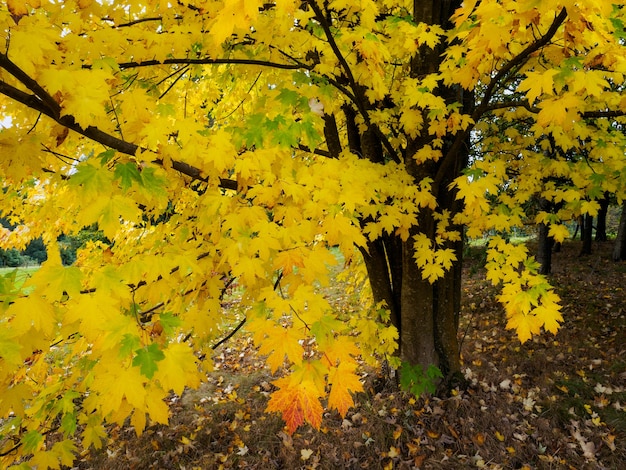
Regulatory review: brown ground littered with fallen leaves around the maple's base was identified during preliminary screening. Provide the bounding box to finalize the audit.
[75,242,626,470]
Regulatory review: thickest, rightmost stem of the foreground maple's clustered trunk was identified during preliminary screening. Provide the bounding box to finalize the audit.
[400,0,464,378]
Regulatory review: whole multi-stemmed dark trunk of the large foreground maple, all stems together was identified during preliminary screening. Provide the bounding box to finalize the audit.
[342,0,473,379]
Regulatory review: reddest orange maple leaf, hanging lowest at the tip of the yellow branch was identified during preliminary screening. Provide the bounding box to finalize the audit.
[266,376,324,434]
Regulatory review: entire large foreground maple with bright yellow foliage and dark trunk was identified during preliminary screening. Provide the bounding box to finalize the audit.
[0,0,626,468]
